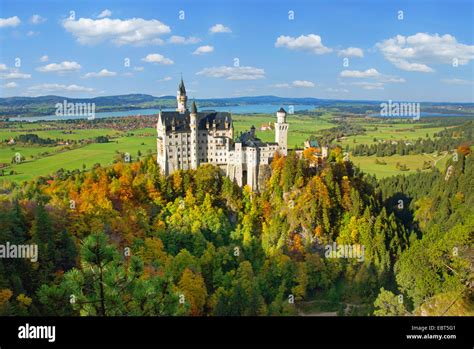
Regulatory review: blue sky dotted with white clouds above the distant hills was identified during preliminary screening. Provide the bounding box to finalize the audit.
[0,0,474,102]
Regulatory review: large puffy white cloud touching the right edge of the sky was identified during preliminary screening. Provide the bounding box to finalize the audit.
[376,33,474,73]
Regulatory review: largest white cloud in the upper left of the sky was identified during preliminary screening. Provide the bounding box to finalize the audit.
[63,18,171,46]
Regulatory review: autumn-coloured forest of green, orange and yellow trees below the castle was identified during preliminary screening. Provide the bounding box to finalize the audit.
[0,148,474,316]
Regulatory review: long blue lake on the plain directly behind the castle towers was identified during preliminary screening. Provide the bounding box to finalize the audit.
[9,104,316,122]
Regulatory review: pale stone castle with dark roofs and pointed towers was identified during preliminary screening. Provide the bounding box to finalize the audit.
[156,78,288,190]
